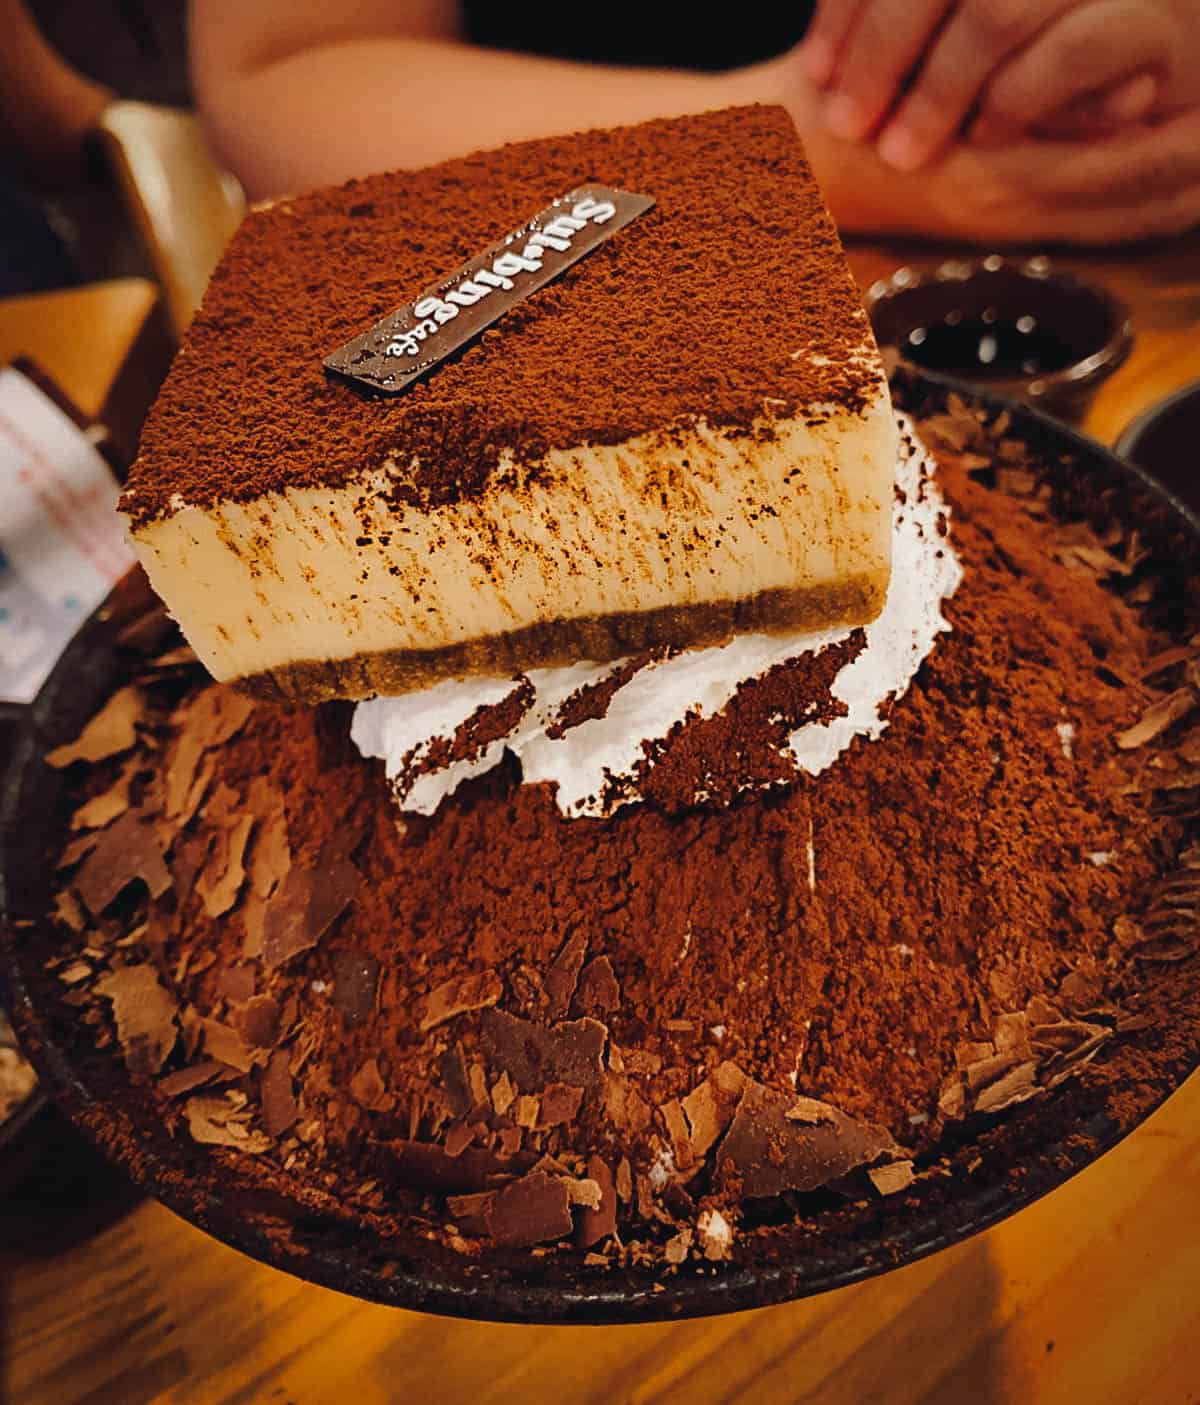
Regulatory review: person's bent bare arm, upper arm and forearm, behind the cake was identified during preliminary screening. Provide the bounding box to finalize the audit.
[191,0,771,195]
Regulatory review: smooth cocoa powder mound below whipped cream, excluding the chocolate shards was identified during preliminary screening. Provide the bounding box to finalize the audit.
[112,449,1162,1137]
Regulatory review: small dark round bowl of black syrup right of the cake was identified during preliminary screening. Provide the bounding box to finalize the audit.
[866,254,1134,420]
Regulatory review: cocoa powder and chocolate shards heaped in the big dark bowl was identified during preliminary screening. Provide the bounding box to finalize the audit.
[42,399,1200,1263]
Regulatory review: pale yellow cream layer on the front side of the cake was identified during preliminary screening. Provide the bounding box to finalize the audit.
[132,396,895,686]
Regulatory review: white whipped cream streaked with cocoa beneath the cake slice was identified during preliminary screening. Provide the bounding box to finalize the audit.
[350,416,963,818]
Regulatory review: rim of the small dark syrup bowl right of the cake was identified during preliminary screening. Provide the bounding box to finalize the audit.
[863,253,1135,398]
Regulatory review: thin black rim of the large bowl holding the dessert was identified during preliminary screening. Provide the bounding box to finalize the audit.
[0,371,1200,1324]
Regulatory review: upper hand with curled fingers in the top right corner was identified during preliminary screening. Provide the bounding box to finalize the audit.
[798,0,1200,170]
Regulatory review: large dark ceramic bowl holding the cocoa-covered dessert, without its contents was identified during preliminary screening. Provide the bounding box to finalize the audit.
[0,372,1200,1322]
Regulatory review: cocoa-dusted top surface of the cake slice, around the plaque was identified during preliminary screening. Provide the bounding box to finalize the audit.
[122,107,878,521]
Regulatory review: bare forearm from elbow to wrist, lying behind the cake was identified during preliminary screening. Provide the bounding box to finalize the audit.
[197,35,773,197]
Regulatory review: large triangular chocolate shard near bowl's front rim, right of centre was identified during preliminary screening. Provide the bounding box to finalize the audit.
[717,1079,896,1198]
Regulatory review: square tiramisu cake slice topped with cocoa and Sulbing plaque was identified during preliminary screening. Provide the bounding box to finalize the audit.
[122,107,896,700]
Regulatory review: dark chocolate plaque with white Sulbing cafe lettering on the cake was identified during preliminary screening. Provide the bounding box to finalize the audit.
[325,184,653,395]
